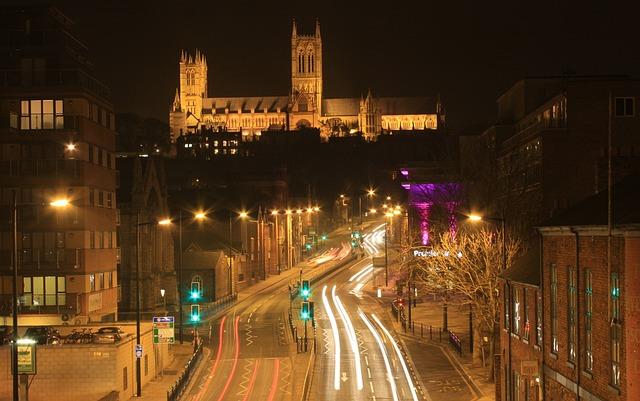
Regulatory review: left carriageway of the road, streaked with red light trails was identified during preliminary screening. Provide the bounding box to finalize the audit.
[184,223,360,401]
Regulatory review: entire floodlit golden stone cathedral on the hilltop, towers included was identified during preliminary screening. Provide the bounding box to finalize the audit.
[169,20,445,142]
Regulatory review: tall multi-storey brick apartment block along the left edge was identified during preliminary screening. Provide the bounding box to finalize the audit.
[0,6,118,325]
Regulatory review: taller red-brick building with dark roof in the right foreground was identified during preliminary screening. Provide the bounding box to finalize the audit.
[539,176,640,401]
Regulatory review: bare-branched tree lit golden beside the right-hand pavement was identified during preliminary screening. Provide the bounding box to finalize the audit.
[405,228,520,378]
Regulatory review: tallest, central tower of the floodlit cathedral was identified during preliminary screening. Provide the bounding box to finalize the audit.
[290,20,322,128]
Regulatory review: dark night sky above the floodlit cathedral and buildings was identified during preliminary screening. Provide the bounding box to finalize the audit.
[46,0,640,128]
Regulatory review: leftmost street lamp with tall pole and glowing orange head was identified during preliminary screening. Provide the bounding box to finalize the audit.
[11,194,71,401]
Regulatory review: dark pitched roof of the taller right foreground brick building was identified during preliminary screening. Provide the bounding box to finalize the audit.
[540,175,640,227]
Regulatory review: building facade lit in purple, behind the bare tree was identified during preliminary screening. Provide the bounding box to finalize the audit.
[402,181,462,245]
